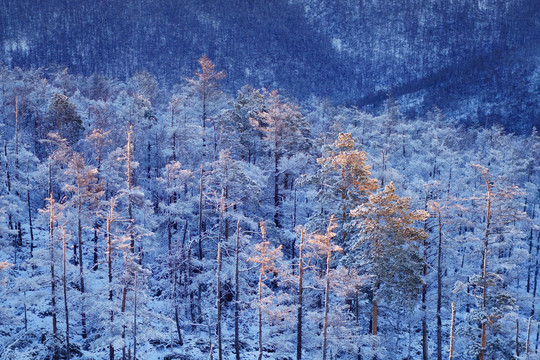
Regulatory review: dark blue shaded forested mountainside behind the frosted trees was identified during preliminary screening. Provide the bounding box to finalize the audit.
[0,0,540,132]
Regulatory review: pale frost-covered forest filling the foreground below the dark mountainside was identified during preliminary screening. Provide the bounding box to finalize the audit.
[0,62,540,359]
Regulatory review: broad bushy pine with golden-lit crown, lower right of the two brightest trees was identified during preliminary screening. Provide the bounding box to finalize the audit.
[351,183,427,358]
